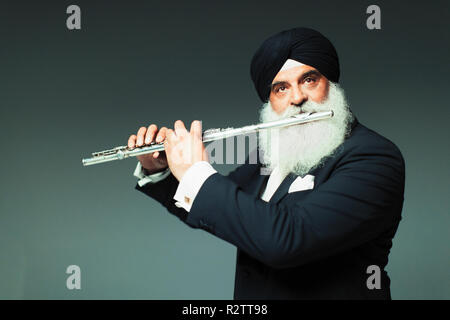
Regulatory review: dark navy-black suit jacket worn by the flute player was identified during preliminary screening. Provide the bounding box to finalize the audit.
[136,119,405,299]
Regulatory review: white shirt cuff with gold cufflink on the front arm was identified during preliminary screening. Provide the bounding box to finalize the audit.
[173,161,217,212]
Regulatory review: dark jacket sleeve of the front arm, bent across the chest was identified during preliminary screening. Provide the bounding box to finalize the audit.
[186,144,404,268]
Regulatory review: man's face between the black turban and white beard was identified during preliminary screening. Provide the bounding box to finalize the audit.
[269,65,329,114]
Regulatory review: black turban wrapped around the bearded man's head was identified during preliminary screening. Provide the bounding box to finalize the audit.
[250,28,339,102]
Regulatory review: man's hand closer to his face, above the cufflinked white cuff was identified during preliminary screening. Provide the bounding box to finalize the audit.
[164,120,208,181]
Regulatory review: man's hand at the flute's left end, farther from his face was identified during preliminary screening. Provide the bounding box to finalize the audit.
[128,124,168,174]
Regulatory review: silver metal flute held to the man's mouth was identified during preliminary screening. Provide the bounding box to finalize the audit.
[81,110,333,166]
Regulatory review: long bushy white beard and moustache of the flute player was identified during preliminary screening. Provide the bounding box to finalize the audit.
[259,82,353,176]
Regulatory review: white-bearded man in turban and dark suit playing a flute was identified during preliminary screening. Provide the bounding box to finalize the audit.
[128,28,405,299]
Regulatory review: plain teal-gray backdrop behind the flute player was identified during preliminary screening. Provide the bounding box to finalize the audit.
[0,0,450,299]
